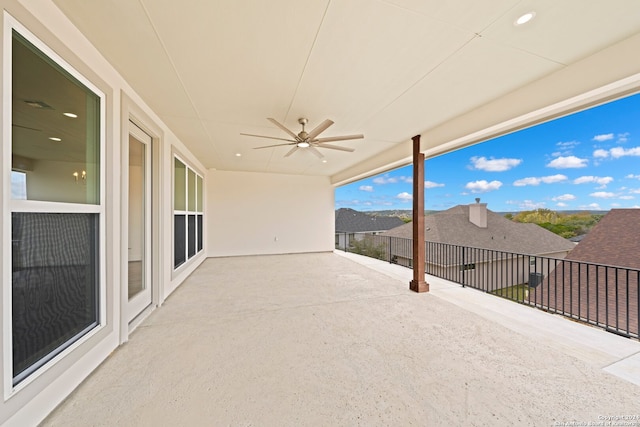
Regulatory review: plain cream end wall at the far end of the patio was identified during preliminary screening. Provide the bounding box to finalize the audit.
[205,170,335,257]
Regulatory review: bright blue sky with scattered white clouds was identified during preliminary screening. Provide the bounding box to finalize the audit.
[335,94,640,212]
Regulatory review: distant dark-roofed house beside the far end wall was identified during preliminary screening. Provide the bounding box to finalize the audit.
[336,208,404,249]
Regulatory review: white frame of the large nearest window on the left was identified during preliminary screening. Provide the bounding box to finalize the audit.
[2,15,107,399]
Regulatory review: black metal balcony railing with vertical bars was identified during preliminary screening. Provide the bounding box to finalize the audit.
[336,233,640,338]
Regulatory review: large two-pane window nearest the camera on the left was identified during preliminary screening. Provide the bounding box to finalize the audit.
[5,30,104,385]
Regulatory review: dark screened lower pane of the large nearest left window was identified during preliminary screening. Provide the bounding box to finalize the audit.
[11,212,99,383]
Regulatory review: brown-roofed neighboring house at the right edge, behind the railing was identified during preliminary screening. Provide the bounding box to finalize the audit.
[535,209,640,336]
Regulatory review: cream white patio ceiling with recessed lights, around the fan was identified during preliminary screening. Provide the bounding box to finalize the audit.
[54,0,640,179]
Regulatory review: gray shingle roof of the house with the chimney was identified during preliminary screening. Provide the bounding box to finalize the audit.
[383,205,575,255]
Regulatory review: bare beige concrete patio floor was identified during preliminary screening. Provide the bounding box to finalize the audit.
[42,253,640,426]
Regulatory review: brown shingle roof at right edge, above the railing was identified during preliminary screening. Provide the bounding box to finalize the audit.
[567,209,640,269]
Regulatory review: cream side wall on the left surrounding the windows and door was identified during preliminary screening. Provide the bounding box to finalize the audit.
[0,0,205,426]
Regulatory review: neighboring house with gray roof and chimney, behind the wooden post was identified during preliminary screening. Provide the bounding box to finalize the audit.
[381,203,575,289]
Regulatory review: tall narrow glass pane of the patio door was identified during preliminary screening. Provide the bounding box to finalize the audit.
[128,136,146,299]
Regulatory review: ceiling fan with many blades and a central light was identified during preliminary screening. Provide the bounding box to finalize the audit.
[240,117,364,159]
